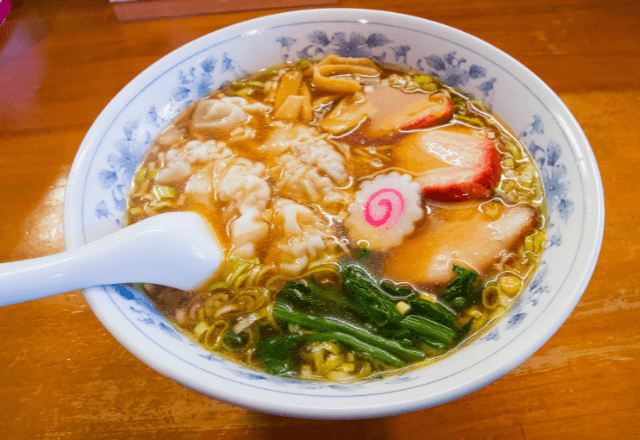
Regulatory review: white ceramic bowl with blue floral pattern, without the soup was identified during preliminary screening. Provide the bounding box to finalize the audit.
[64,9,604,419]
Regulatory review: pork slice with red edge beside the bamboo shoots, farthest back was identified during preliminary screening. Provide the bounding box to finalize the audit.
[365,87,453,137]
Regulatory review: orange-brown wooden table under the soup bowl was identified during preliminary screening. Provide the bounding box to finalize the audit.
[0,0,640,440]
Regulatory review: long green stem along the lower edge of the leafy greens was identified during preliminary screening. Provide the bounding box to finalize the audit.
[273,302,425,362]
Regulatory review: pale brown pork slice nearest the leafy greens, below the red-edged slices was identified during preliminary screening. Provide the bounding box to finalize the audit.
[383,202,538,285]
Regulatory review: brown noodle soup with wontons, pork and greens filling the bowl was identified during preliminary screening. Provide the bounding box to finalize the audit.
[128,56,545,380]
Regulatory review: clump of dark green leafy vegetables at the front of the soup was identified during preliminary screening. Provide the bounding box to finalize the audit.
[258,262,481,376]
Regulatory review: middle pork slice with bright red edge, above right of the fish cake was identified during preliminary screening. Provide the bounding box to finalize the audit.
[392,125,500,202]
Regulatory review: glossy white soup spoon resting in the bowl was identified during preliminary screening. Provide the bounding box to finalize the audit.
[0,212,222,306]
